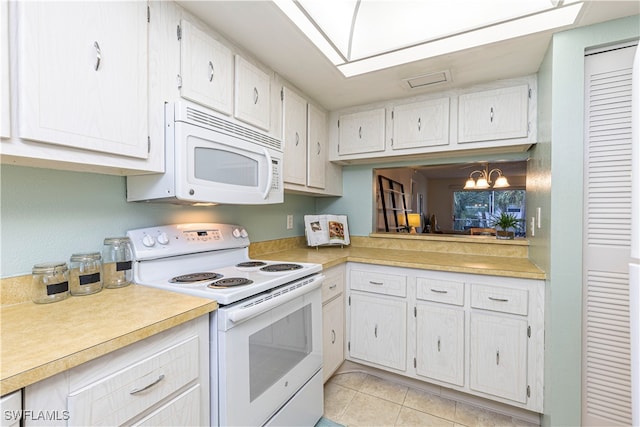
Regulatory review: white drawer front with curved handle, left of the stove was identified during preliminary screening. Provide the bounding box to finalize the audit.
[67,337,199,426]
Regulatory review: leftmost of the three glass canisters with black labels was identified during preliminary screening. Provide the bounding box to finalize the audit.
[31,262,69,304]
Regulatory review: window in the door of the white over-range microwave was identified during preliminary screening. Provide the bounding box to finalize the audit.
[194,147,260,187]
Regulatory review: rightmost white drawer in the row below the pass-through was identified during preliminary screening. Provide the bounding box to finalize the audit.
[471,283,529,316]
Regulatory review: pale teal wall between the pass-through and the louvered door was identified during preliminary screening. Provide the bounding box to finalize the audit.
[527,16,640,426]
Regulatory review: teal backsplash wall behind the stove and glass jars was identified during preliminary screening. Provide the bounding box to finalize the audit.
[0,165,315,277]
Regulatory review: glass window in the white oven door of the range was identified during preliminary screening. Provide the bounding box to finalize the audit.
[249,304,313,402]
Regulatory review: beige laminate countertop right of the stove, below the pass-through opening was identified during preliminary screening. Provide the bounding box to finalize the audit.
[258,246,545,279]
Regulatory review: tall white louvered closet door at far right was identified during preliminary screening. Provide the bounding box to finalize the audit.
[582,41,640,426]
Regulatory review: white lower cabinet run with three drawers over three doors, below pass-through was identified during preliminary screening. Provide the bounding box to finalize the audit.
[346,263,544,413]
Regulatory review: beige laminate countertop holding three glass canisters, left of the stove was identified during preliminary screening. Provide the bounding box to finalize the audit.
[0,285,218,395]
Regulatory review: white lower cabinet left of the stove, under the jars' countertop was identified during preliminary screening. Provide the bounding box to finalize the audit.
[24,316,210,426]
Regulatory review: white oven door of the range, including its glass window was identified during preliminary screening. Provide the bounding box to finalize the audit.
[218,276,323,426]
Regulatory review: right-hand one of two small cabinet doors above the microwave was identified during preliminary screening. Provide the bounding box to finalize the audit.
[235,55,271,131]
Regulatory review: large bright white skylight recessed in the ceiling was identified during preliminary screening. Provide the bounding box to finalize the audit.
[273,0,582,77]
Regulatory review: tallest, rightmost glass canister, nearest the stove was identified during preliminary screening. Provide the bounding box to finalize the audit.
[102,237,132,289]
